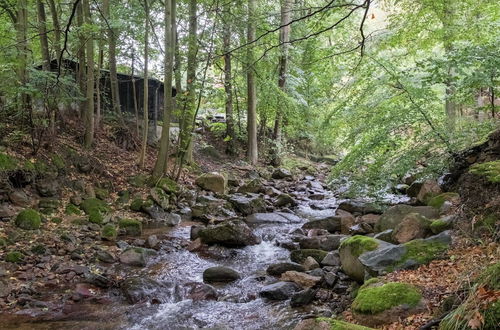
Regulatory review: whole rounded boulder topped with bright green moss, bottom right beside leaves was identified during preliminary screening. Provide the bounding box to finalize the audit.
[351,281,424,327]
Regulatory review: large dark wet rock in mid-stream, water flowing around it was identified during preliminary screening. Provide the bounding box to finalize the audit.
[199,220,260,247]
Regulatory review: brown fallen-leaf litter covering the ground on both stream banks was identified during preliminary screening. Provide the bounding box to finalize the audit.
[0,122,500,330]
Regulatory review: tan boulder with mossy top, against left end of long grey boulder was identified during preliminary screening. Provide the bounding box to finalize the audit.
[339,235,389,282]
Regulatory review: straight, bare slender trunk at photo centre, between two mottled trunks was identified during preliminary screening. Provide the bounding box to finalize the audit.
[246,0,258,165]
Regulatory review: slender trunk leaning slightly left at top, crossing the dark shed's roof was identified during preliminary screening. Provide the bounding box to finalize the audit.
[103,0,121,116]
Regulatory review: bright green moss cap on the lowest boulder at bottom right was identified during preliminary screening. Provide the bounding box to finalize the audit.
[351,282,422,314]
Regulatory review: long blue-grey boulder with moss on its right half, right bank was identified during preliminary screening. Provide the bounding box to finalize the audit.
[359,231,451,276]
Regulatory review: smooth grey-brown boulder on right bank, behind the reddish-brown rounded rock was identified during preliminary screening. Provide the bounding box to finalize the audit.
[374,204,439,233]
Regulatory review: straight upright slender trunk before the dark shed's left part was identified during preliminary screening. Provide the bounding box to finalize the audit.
[83,0,94,148]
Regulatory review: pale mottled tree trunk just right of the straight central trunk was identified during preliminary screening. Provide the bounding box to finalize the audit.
[273,0,292,166]
